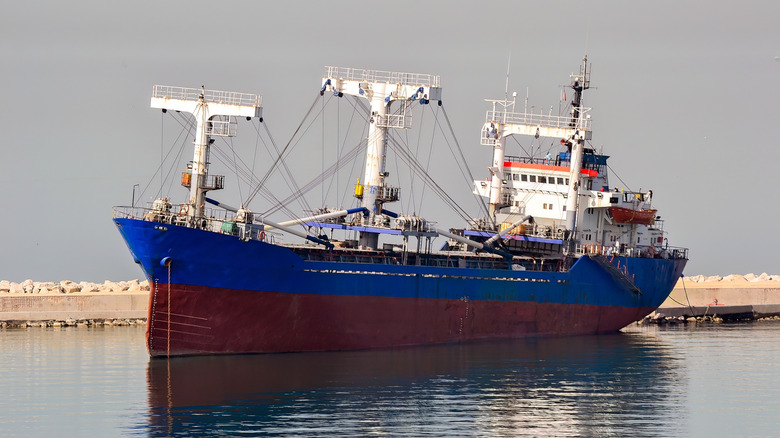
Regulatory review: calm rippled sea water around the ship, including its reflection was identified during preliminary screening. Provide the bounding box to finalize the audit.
[0,321,780,437]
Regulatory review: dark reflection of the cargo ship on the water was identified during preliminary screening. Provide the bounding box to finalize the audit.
[146,333,687,436]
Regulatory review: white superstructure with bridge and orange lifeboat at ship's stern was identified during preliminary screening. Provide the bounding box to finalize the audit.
[474,57,663,254]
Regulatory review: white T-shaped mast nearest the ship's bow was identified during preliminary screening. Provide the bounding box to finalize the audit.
[151,85,263,225]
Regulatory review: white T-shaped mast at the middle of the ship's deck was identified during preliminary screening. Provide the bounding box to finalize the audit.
[321,67,441,249]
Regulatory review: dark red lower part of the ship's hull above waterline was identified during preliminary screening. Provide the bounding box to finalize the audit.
[146,284,654,356]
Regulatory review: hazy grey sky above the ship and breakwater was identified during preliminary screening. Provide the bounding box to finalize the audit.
[0,0,780,282]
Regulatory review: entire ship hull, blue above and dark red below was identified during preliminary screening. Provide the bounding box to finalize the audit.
[114,219,687,355]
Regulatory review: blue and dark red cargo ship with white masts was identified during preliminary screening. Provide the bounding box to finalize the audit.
[113,57,688,357]
